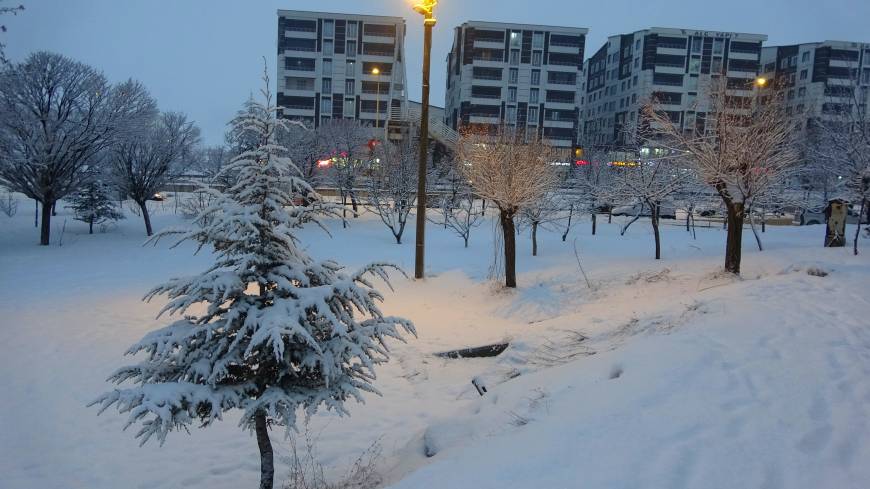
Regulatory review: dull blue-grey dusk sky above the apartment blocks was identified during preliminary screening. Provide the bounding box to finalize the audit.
[2,0,870,144]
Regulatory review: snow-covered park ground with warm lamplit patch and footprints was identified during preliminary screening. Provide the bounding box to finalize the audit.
[0,195,870,489]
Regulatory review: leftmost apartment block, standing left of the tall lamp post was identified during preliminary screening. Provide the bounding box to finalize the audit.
[277,10,408,132]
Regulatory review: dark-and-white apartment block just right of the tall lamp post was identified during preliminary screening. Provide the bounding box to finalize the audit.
[445,21,588,153]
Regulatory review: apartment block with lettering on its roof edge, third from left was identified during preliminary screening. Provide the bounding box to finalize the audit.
[578,27,767,148]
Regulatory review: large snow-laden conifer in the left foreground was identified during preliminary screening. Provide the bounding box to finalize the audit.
[92,67,415,489]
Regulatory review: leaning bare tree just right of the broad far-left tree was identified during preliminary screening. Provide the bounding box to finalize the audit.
[111,112,199,236]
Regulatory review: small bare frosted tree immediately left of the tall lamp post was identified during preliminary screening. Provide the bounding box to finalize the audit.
[368,138,420,244]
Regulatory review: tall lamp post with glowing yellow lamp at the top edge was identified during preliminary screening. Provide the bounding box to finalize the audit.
[414,0,438,279]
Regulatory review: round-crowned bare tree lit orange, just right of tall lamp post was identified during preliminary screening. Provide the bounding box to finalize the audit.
[459,127,558,287]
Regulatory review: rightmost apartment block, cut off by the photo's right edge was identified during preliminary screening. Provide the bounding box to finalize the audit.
[761,41,870,133]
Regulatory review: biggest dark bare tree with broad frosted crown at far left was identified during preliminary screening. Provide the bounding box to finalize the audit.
[0,52,156,246]
